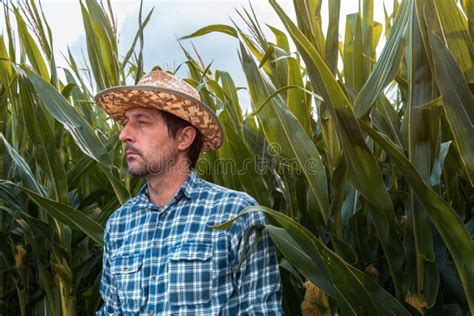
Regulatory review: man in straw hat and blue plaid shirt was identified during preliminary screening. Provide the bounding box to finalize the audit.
[96,71,282,315]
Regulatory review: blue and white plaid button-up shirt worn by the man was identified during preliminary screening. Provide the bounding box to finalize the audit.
[97,170,283,315]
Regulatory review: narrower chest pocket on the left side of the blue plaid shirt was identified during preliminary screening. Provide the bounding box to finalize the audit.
[110,254,145,312]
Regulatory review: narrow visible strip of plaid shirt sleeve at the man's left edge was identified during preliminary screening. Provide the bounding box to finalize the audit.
[96,223,122,316]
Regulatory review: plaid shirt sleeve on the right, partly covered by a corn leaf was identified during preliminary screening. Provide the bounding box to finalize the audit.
[231,202,283,315]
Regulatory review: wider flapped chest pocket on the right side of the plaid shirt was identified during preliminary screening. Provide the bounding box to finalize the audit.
[168,243,212,306]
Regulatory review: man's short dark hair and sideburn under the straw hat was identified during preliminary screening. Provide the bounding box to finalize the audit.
[160,111,202,168]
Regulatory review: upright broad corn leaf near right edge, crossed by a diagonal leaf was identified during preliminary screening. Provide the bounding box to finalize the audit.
[405,7,439,308]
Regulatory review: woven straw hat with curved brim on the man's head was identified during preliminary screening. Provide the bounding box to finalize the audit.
[95,70,224,151]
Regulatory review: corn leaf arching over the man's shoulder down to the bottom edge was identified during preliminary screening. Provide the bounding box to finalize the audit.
[213,206,409,315]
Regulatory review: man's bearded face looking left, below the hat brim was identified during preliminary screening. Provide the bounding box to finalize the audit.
[119,108,178,178]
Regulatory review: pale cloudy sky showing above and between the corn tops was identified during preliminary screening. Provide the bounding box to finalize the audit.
[0,0,393,107]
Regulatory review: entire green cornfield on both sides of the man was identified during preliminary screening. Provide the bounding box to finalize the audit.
[0,0,474,315]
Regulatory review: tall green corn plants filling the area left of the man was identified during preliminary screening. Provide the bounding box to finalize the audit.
[0,0,146,315]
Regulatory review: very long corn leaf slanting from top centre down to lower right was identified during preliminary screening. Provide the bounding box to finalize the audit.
[270,0,405,297]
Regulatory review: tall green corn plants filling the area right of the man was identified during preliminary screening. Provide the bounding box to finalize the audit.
[184,0,474,315]
